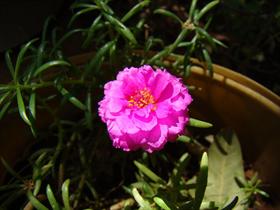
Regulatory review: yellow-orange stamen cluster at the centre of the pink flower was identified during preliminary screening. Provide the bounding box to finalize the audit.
[128,88,156,110]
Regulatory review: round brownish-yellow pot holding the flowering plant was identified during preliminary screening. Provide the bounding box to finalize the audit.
[0,53,280,206]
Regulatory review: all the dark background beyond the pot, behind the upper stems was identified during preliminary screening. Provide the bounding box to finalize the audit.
[0,0,280,95]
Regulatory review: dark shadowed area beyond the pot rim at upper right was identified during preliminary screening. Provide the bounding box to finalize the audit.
[212,0,280,94]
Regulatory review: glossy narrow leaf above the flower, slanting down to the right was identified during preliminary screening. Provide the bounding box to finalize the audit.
[103,13,137,44]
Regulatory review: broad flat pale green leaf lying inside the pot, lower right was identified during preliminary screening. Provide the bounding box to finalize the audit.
[205,130,246,210]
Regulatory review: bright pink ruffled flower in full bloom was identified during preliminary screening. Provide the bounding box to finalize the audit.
[98,65,192,153]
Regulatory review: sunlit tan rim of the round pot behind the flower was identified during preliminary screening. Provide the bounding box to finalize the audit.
[70,51,280,117]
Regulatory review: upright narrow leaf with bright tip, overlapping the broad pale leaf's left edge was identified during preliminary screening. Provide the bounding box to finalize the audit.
[193,152,208,210]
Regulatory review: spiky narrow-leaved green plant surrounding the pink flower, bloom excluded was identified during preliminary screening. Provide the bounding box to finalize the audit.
[0,0,270,210]
